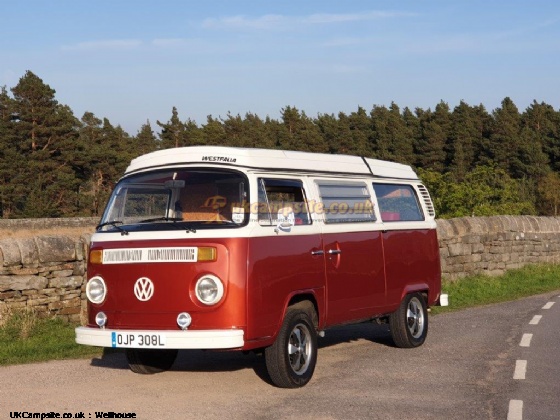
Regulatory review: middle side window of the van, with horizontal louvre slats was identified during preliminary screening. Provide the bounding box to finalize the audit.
[317,181,375,223]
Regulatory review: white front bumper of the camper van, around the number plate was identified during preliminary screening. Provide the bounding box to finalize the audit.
[76,327,244,349]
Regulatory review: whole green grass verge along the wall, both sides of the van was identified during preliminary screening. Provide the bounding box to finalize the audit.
[0,265,560,365]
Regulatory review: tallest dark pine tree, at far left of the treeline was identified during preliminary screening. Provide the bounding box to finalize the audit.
[11,71,79,217]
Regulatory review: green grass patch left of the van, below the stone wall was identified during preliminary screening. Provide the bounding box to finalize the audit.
[0,312,102,365]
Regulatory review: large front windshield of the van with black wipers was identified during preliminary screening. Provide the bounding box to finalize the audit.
[98,169,248,232]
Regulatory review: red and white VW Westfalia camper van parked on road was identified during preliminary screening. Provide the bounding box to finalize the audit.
[76,146,441,388]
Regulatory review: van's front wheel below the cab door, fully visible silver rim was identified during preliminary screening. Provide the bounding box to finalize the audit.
[264,302,317,388]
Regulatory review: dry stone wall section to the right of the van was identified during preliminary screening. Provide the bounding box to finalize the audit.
[438,216,560,280]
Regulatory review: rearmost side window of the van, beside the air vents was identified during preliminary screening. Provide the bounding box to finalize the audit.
[373,183,424,222]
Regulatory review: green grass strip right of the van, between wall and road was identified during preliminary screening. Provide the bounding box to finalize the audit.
[433,265,560,313]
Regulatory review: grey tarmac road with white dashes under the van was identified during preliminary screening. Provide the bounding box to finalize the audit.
[0,292,560,420]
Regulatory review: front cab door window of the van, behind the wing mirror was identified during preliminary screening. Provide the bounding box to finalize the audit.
[259,178,311,226]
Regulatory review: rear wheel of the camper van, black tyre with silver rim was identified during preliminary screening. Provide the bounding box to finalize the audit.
[389,293,428,348]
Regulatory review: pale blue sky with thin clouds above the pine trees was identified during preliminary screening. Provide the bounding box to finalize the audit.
[0,0,560,134]
